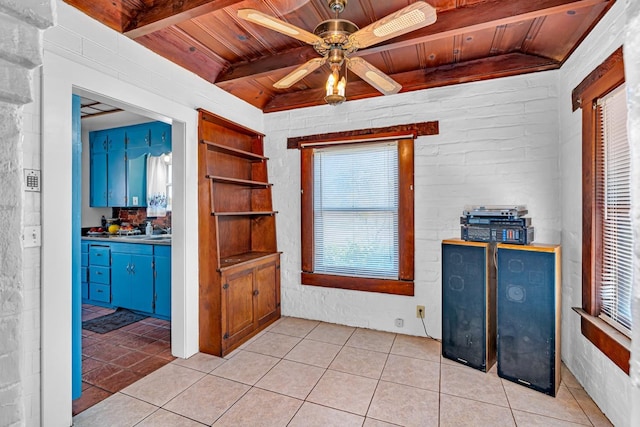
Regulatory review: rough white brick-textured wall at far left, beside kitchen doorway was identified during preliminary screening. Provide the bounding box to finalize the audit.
[0,0,53,426]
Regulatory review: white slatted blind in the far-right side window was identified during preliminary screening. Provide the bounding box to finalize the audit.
[597,85,633,334]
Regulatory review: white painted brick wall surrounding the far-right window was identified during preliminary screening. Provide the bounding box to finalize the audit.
[558,1,640,426]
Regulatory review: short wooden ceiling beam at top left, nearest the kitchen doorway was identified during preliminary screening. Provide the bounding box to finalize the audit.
[124,0,242,39]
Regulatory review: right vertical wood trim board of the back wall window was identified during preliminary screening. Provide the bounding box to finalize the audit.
[398,139,415,280]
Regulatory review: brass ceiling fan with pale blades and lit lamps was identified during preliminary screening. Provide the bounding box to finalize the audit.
[238,0,436,105]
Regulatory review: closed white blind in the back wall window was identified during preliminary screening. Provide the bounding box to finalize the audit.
[313,142,399,279]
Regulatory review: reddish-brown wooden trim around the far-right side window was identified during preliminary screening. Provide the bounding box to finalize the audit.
[572,48,631,374]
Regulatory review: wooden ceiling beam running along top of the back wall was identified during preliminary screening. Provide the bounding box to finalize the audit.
[263,53,561,113]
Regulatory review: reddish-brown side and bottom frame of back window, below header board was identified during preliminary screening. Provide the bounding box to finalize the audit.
[300,134,415,296]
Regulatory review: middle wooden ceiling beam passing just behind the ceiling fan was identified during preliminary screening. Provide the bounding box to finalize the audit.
[216,0,611,83]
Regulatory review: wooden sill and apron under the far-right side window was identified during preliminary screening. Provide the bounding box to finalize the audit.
[573,307,631,375]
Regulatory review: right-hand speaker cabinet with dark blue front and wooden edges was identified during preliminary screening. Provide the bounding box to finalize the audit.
[497,243,561,396]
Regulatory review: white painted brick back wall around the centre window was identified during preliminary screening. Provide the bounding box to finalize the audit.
[265,72,560,337]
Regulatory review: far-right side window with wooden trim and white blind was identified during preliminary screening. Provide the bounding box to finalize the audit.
[573,49,633,373]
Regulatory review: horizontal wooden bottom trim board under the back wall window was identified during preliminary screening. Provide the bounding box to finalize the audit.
[302,273,414,296]
